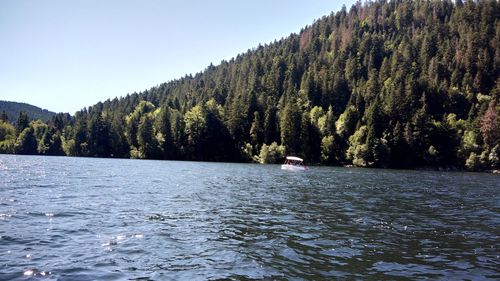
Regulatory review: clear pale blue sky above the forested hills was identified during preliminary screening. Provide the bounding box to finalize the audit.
[0,0,355,114]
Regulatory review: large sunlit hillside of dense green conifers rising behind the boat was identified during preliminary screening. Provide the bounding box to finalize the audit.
[0,0,500,170]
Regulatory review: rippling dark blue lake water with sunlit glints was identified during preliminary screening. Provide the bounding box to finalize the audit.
[0,155,500,280]
